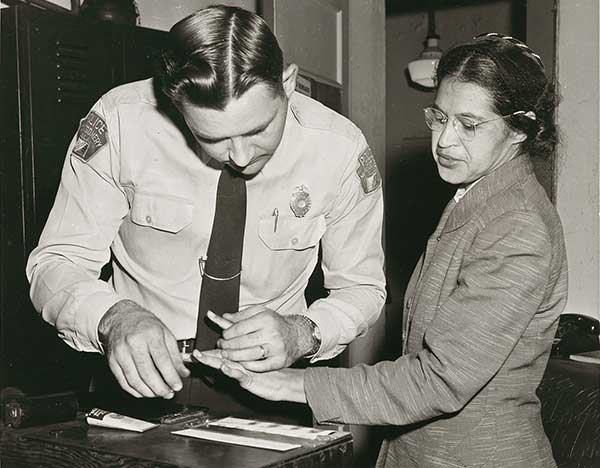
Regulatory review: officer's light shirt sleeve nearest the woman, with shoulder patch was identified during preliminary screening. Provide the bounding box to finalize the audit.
[306,136,385,361]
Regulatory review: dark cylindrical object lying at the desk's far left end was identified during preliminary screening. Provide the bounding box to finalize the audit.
[0,387,79,428]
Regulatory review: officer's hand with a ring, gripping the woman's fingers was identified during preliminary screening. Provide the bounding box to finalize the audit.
[208,306,312,372]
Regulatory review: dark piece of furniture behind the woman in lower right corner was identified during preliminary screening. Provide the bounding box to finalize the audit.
[538,357,600,468]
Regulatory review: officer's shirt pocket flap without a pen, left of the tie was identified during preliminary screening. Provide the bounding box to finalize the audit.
[131,193,193,233]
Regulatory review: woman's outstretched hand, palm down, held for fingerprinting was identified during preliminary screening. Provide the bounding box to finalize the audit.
[192,349,306,403]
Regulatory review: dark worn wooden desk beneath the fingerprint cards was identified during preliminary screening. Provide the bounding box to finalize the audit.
[0,420,352,468]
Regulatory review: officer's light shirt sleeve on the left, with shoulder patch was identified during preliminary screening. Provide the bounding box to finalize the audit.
[26,100,128,352]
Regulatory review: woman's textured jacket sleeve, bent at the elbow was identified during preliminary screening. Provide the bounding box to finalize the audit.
[305,212,551,425]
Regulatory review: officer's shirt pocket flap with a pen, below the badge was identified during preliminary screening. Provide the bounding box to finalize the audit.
[258,216,325,250]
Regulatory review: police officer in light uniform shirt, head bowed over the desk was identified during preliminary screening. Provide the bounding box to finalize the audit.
[27,6,385,410]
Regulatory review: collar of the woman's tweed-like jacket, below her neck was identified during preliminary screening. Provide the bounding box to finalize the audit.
[443,155,533,233]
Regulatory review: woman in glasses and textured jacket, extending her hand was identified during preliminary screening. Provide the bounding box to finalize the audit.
[196,33,567,468]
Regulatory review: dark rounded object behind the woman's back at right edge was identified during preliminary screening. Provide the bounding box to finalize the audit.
[552,314,600,357]
